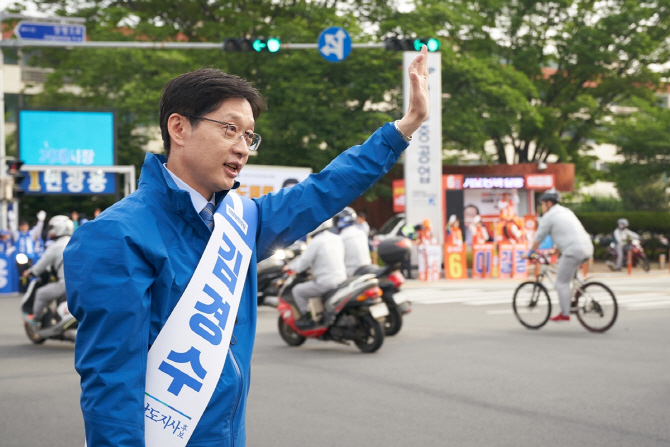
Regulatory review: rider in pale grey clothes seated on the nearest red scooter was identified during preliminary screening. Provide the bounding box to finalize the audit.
[286,219,347,330]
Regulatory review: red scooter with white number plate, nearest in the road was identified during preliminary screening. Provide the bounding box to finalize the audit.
[277,273,388,353]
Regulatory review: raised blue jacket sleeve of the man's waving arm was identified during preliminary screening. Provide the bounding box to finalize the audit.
[254,123,408,260]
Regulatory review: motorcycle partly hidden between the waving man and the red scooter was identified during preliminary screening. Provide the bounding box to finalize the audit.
[256,241,305,307]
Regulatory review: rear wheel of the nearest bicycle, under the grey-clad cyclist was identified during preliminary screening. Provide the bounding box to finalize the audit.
[572,282,619,332]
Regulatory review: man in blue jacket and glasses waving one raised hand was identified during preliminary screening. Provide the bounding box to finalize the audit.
[64,47,428,447]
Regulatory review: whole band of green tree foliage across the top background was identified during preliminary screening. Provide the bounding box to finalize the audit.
[10,0,670,191]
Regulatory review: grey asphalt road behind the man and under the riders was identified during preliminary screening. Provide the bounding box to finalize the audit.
[0,273,670,447]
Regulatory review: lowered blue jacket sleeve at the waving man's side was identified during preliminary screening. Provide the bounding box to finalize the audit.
[64,218,153,447]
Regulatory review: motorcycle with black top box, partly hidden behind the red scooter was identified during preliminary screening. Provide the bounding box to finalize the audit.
[355,237,412,336]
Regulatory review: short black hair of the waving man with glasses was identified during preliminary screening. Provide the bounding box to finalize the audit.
[159,68,267,158]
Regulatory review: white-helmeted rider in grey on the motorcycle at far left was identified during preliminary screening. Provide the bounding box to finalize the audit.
[23,216,74,328]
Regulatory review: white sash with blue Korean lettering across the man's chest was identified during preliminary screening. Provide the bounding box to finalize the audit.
[144,192,258,447]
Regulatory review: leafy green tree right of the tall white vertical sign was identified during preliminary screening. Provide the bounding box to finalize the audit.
[406,0,670,175]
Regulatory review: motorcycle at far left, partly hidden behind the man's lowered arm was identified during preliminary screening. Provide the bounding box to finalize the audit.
[21,258,78,345]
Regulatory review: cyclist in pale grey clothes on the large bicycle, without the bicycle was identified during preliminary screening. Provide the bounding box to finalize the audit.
[528,189,593,321]
